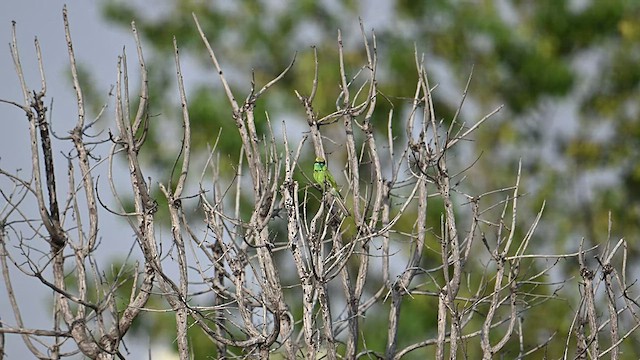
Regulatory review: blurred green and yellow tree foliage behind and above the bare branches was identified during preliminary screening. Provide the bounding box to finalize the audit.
[85,0,640,354]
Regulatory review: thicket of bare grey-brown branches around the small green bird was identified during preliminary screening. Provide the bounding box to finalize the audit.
[0,9,640,359]
